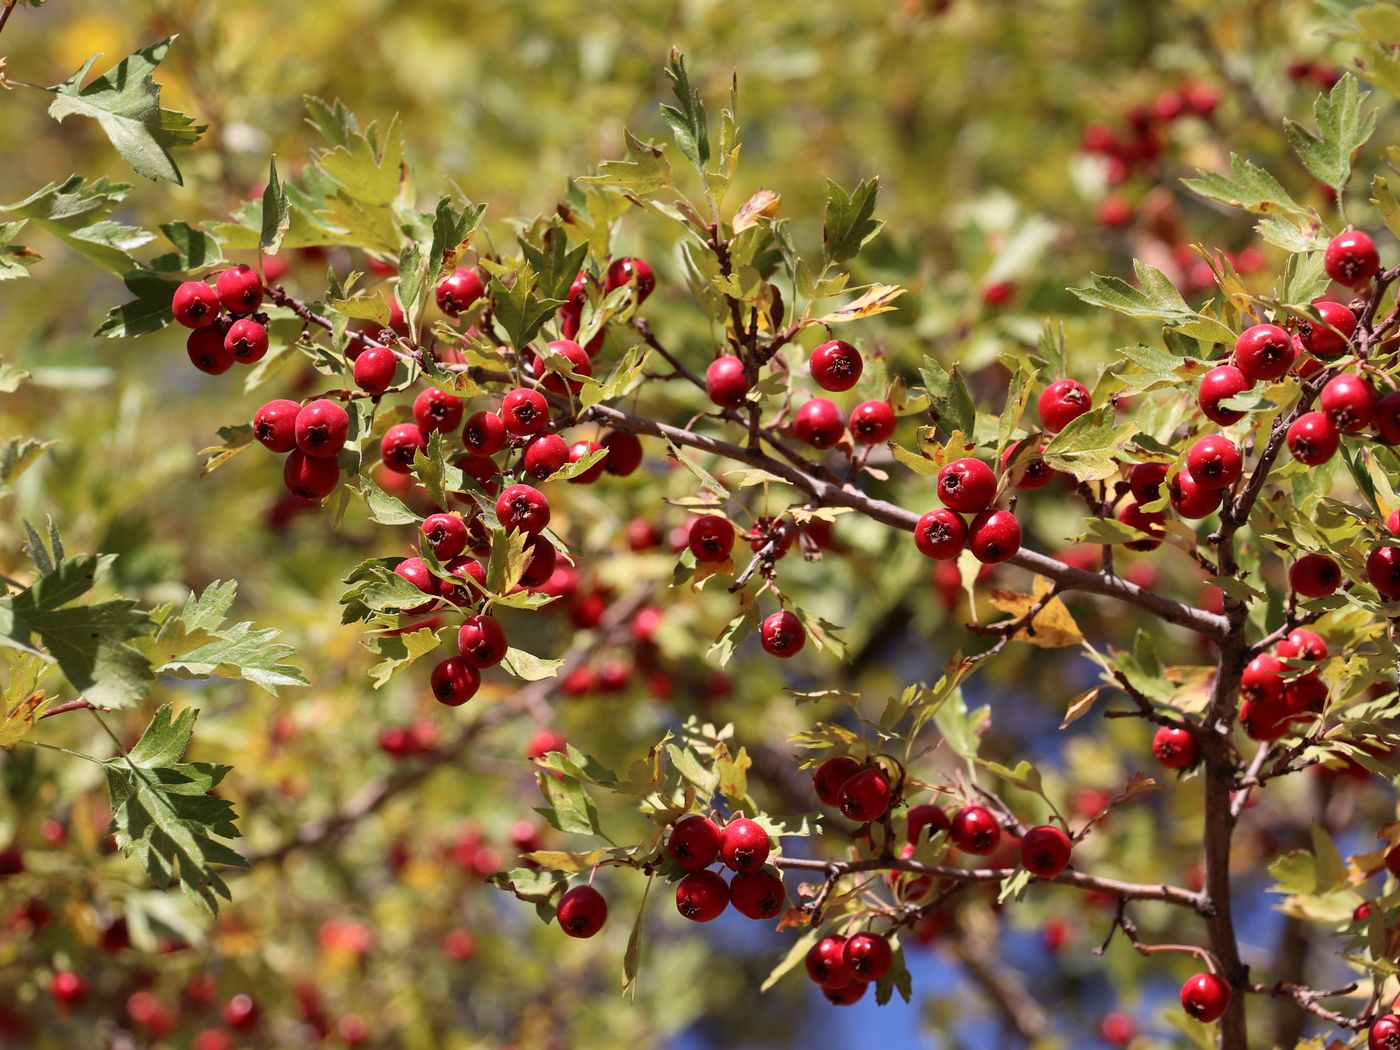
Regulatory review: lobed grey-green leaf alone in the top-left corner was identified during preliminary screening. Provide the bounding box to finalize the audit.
[48,36,203,185]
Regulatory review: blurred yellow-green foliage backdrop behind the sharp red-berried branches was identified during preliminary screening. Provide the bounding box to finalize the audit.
[0,0,1383,1050]
